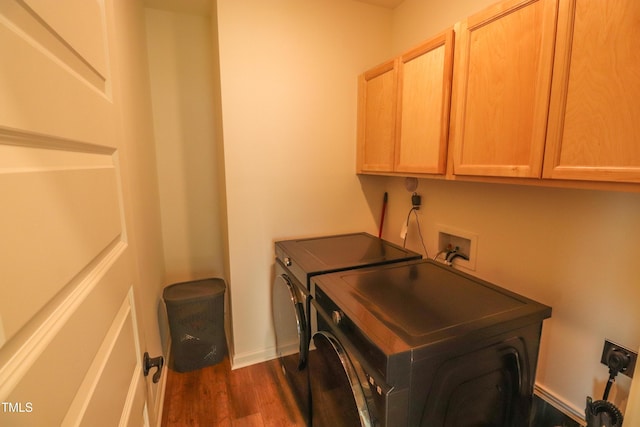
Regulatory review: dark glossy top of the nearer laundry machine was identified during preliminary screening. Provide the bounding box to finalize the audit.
[313,260,551,358]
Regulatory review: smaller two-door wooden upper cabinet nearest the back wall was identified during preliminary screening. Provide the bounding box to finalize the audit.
[357,29,454,174]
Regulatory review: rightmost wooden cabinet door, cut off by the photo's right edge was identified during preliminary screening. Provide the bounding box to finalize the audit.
[544,0,640,182]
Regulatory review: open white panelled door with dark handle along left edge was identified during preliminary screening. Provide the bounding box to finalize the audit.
[0,0,148,427]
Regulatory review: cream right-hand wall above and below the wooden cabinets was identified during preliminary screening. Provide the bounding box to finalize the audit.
[385,0,640,414]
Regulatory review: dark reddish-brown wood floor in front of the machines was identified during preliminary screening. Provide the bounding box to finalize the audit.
[162,356,304,427]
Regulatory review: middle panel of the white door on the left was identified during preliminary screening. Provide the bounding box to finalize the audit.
[0,146,123,346]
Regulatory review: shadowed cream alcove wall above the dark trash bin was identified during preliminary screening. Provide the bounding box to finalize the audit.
[146,8,224,284]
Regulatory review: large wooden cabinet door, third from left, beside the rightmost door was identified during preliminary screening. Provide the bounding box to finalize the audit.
[452,0,557,177]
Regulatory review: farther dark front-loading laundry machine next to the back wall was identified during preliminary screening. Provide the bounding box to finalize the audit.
[272,233,422,421]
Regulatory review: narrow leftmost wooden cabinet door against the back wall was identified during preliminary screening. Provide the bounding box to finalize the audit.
[356,60,398,173]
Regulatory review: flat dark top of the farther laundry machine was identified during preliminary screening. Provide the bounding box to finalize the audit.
[275,233,422,276]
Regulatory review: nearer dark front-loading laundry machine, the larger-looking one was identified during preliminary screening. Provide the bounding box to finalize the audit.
[307,260,551,427]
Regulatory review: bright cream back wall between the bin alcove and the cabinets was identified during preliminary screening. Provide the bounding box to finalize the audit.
[217,0,391,366]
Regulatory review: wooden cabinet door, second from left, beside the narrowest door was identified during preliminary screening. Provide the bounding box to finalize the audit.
[395,30,454,174]
